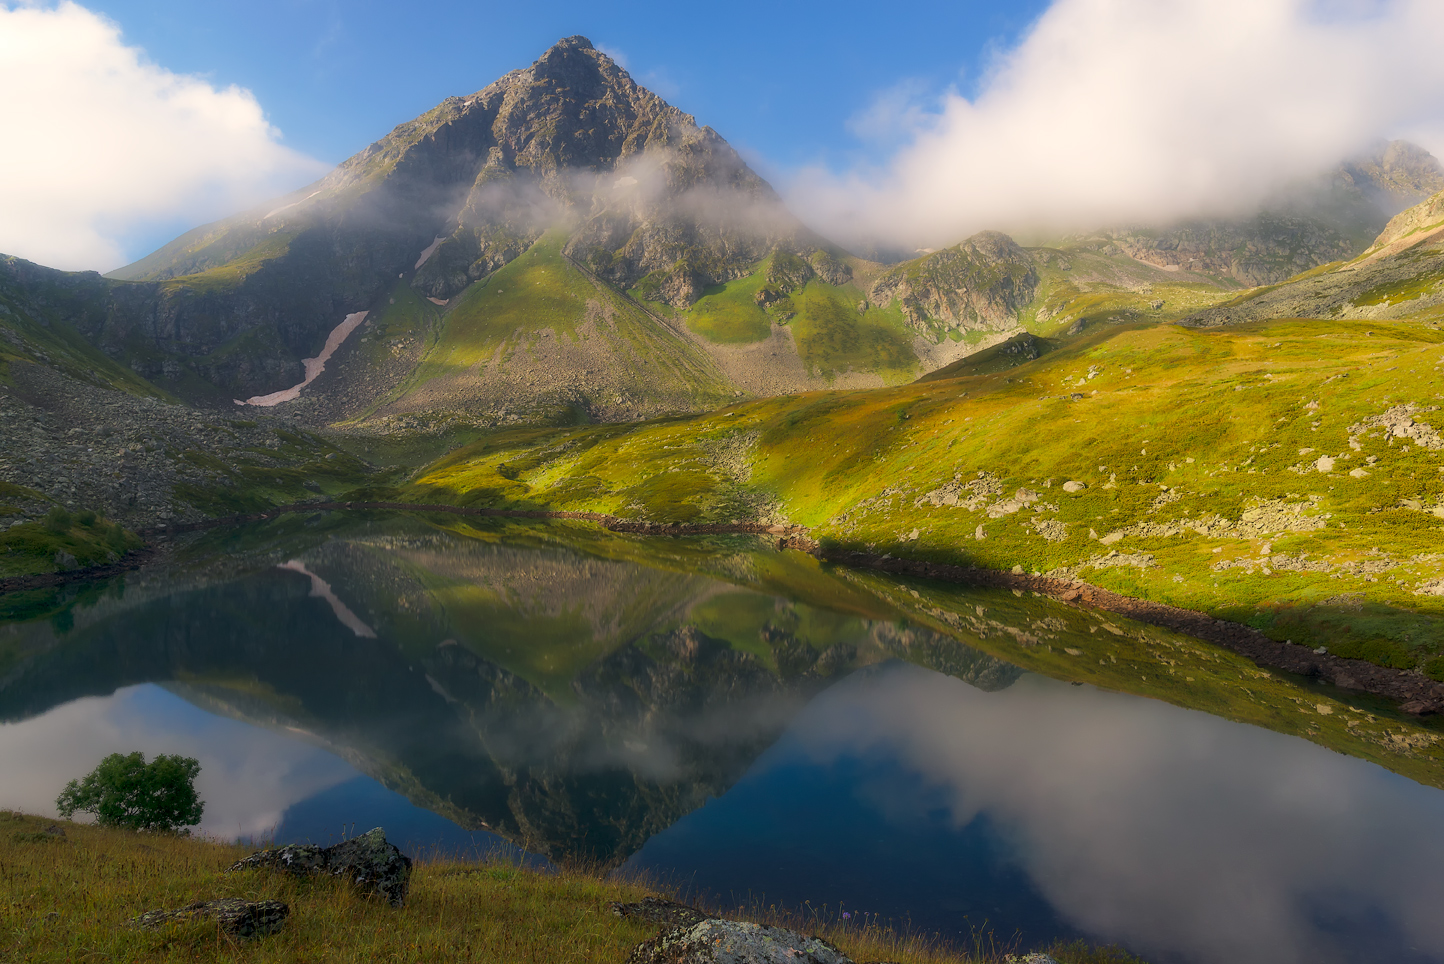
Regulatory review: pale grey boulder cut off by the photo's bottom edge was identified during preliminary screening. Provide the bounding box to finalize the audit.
[627,919,852,964]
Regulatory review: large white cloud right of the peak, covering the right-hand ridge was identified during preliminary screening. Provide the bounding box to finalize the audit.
[790,0,1444,247]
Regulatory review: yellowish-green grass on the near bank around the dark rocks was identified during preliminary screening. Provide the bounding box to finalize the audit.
[0,812,1114,964]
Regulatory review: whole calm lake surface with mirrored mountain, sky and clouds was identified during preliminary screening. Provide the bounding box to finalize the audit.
[0,520,1444,964]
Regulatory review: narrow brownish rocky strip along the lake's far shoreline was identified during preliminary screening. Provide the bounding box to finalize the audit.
[8,501,1444,716]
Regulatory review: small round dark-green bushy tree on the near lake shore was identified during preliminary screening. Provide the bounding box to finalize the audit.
[55,752,205,831]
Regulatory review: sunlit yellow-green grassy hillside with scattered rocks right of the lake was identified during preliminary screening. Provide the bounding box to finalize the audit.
[406,313,1444,675]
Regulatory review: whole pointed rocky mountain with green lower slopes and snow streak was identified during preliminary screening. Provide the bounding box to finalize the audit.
[0,38,1062,431]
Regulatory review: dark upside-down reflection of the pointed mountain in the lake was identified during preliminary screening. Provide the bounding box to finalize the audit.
[0,534,1019,866]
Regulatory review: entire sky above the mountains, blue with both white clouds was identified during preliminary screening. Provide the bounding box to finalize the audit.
[0,0,1444,270]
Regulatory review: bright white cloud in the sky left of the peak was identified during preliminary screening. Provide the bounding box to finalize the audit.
[0,3,325,270]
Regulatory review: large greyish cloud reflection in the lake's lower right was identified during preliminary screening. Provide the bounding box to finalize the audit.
[785,665,1444,964]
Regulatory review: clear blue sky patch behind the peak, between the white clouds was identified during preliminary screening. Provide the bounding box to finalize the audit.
[85,0,1047,176]
